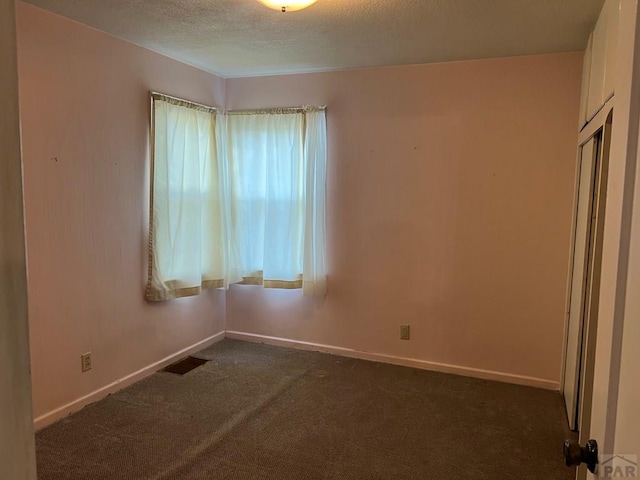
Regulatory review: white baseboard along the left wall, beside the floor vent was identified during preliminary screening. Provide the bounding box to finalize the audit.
[33,331,225,430]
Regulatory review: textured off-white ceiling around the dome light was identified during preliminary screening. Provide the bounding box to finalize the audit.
[22,0,603,77]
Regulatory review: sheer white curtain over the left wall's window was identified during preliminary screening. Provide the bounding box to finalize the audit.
[146,96,225,301]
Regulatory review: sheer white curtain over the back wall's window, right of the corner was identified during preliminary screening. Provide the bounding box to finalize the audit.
[226,108,327,295]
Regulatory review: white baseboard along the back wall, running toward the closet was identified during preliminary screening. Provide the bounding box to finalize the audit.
[226,330,560,391]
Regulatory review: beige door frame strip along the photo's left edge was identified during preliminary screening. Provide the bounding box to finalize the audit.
[0,0,37,480]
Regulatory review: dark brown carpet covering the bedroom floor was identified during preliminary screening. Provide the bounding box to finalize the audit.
[36,340,574,480]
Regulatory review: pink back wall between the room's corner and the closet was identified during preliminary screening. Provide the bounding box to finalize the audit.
[227,53,582,387]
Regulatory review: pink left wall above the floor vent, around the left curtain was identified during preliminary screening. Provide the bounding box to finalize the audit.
[17,2,225,424]
